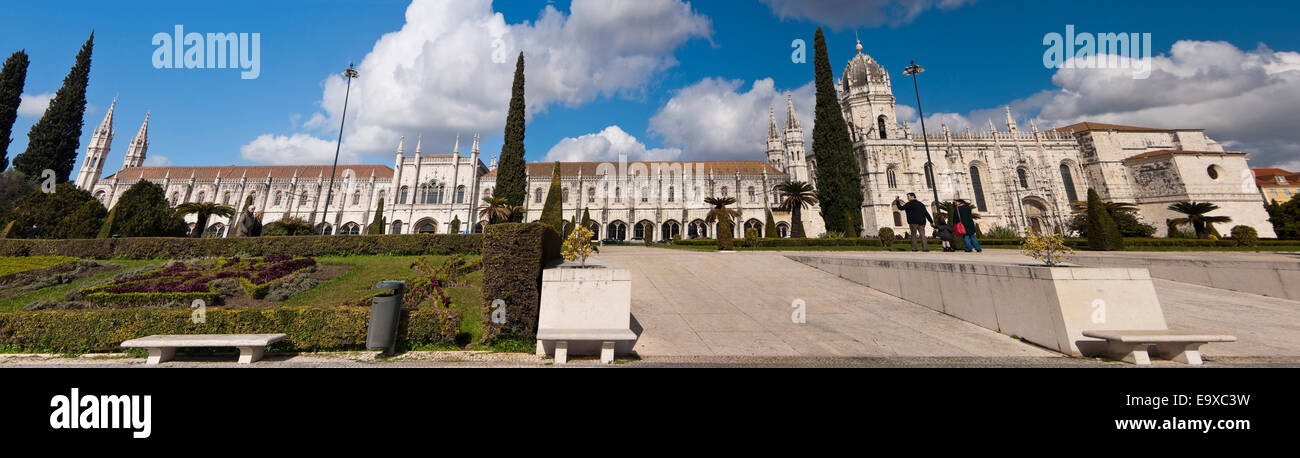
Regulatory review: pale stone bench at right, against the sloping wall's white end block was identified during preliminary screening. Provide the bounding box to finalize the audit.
[1083,330,1236,364]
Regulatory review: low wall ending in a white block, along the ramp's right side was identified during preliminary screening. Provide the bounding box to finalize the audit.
[787,255,1167,355]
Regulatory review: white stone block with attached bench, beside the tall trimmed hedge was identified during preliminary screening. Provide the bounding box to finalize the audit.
[537,259,641,355]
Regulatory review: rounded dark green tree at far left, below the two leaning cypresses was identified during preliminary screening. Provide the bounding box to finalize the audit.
[8,182,107,238]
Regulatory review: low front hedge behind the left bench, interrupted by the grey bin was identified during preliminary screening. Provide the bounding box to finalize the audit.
[0,306,460,353]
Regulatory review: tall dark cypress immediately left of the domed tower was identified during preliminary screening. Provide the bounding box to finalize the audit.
[813,27,863,234]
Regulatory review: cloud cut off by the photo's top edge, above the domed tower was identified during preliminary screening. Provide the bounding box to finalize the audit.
[762,0,975,30]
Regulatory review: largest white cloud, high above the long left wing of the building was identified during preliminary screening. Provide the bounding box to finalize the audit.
[241,0,712,164]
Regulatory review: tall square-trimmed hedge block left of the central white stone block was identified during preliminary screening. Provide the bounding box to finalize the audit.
[482,222,560,338]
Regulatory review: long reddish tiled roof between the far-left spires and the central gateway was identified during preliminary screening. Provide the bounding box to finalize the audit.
[101,164,393,181]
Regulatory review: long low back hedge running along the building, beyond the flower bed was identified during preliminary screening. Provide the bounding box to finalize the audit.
[0,234,484,259]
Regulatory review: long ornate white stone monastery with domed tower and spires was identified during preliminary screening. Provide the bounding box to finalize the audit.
[77,38,1274,241]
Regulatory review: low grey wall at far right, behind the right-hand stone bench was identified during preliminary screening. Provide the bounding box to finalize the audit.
[1070,254,1300,301]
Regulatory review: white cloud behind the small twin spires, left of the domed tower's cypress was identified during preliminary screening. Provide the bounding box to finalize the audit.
[649,78,815,160]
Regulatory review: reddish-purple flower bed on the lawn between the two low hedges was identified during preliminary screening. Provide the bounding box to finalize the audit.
[81,255,316,306]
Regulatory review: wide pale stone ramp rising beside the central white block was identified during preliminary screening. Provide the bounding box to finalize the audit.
[598,246,1060,359]
